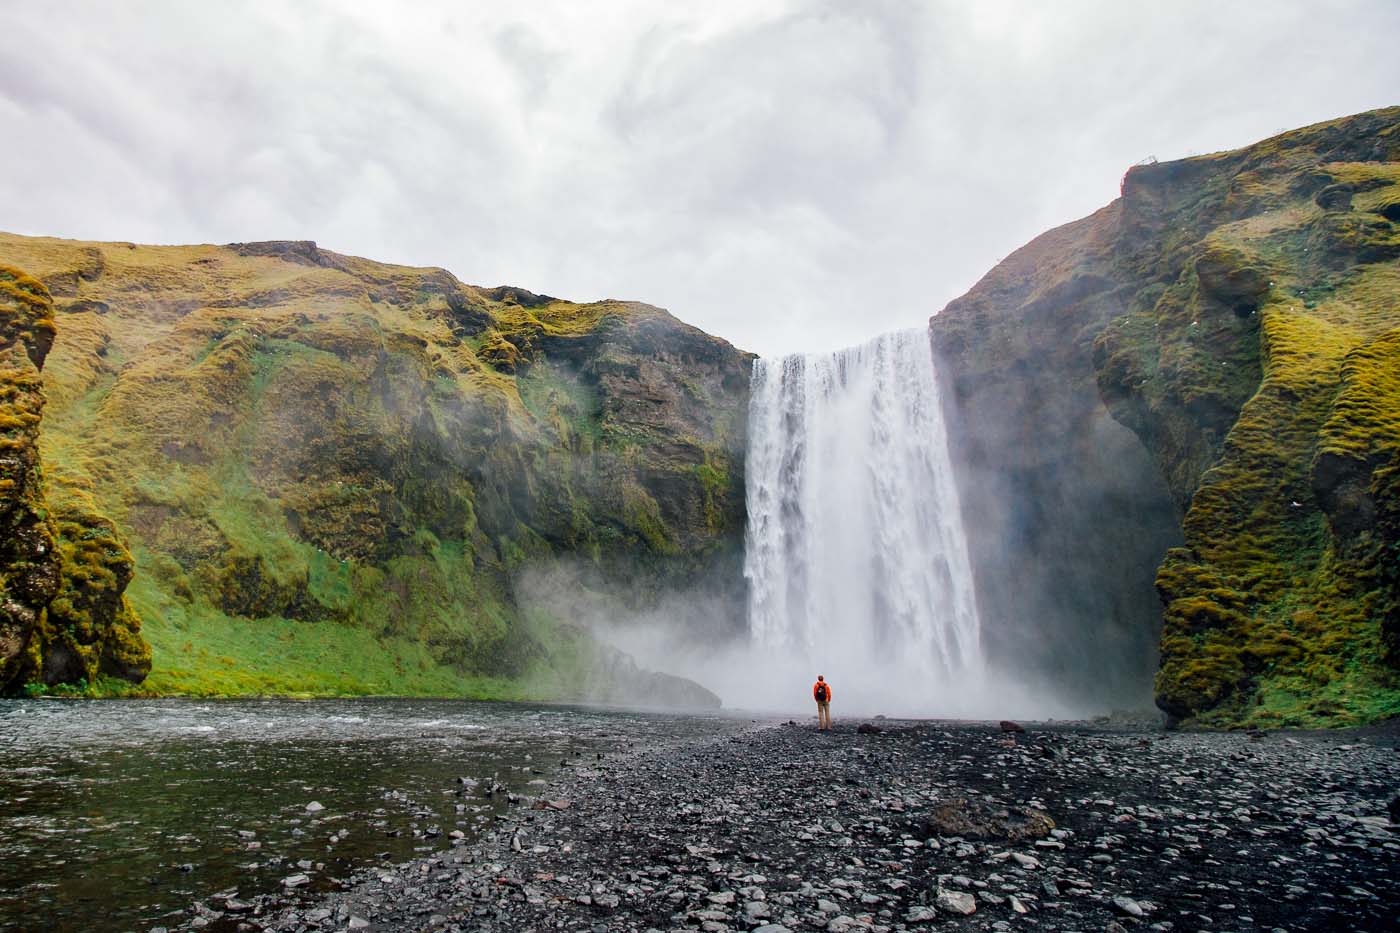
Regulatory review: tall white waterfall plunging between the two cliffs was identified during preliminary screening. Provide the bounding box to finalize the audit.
[745,329,984,713]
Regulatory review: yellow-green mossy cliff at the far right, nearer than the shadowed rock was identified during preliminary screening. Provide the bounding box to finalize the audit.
[1096,109,1400,726]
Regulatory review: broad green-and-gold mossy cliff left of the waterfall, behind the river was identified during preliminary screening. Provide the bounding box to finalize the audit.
[0,234,749,696]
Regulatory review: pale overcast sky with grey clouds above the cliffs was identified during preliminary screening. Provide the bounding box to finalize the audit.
[0,0,1400,354]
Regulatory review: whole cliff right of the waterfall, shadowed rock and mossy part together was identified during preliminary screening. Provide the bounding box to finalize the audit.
[932,108,1400,726]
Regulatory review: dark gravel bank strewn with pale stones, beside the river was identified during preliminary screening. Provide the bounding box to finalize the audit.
[195,721,1400,933]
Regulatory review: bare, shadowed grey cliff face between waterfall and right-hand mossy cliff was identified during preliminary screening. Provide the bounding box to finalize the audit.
[931,205,1180,707]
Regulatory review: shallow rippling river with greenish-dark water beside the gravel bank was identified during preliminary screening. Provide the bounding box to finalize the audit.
[0,699,749,930]
